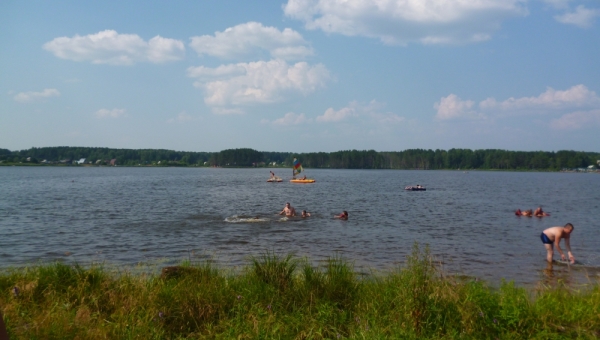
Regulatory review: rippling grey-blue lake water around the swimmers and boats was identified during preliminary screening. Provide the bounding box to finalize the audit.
[0,167,600,285]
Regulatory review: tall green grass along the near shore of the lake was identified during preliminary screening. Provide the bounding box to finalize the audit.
[0,245,600,339]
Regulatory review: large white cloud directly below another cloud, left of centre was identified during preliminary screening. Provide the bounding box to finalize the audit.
[187,59,331,106]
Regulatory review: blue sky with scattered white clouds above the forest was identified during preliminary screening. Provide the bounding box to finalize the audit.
[0,0,600,152]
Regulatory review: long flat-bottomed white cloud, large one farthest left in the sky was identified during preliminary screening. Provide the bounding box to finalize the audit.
[43,30,185,65]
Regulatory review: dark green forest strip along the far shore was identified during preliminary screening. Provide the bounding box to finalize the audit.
[0,146,600,171]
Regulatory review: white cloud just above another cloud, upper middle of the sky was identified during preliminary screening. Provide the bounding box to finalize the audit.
[190,22,314,60]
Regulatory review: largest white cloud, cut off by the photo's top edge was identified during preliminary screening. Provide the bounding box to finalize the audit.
[284,0,528,45]
